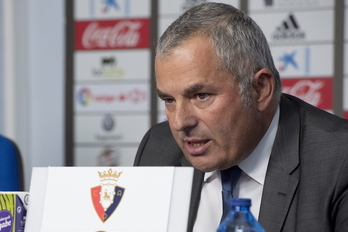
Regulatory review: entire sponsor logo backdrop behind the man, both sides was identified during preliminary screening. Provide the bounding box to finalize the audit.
[67,0,348,166]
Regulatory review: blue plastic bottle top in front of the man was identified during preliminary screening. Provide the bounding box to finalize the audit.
[217,198,265,232]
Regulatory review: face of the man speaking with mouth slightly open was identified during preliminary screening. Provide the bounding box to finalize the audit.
[155,37,260,171]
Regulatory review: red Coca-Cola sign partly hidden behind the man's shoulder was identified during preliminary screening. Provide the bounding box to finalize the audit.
[282,78,332,109]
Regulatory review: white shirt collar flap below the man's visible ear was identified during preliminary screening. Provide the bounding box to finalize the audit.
[238,106,279,185]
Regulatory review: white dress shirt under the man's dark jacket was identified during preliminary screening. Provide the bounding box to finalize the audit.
[193,106,279,232]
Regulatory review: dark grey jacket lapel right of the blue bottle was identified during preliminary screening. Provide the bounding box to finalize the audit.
[259,96,301,231]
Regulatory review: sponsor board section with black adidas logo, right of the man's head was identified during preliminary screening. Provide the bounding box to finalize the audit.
[249,0,334,111]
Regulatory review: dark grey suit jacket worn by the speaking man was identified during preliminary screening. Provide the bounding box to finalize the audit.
[134,94,348,232]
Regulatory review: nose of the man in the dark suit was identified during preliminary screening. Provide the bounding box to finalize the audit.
[167,102,198,131]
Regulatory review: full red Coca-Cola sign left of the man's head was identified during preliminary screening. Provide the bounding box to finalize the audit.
[75,19,150,50]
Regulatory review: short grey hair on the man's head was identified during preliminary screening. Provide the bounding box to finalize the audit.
[156,2,281,108]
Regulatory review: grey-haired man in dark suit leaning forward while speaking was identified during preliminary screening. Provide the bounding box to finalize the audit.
[134,3,348,232]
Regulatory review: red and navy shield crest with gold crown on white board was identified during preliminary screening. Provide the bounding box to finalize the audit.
[91,168,125,222]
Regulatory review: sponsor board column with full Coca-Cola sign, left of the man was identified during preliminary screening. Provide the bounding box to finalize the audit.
[70,0,151,166]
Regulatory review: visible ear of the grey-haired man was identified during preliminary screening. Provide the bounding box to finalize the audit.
[253,68,275,112]
